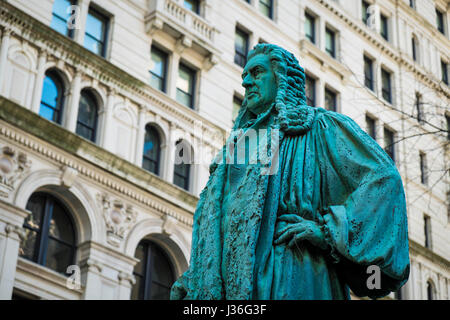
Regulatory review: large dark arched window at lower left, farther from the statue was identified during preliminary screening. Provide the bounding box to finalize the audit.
[20,192,76,273]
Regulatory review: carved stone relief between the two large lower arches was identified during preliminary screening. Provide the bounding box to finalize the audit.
[97,193,137,247]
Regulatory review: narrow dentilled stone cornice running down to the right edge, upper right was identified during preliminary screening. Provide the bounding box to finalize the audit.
[318,0,450,98]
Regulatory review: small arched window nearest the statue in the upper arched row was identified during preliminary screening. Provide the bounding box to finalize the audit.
[173,140,193,190]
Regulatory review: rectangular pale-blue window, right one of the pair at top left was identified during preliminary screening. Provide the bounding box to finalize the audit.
[84,8,109,57]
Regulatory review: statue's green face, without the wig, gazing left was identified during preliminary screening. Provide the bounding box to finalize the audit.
[242,54,278,115]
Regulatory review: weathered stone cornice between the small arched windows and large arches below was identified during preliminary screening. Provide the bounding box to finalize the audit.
[0,96,198,227]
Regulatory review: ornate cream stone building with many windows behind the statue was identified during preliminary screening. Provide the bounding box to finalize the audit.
[0,0,450,299]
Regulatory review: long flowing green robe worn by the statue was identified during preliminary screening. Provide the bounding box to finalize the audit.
[172,106,409,299]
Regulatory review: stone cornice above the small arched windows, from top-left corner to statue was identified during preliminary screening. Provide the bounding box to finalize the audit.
[0,0,225,140]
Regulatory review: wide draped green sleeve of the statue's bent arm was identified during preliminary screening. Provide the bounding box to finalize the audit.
[313,109,409,298]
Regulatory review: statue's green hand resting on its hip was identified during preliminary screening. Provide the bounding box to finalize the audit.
[274,214,327,249]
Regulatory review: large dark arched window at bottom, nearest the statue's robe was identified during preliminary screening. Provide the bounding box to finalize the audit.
[131,240,175,300]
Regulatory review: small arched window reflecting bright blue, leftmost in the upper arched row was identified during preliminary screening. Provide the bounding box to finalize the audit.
[39,71,64,124]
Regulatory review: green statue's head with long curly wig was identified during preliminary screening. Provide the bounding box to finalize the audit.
[235,44,306,132]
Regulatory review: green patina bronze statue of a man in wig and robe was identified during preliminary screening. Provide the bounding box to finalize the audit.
[171,44,409,299]
